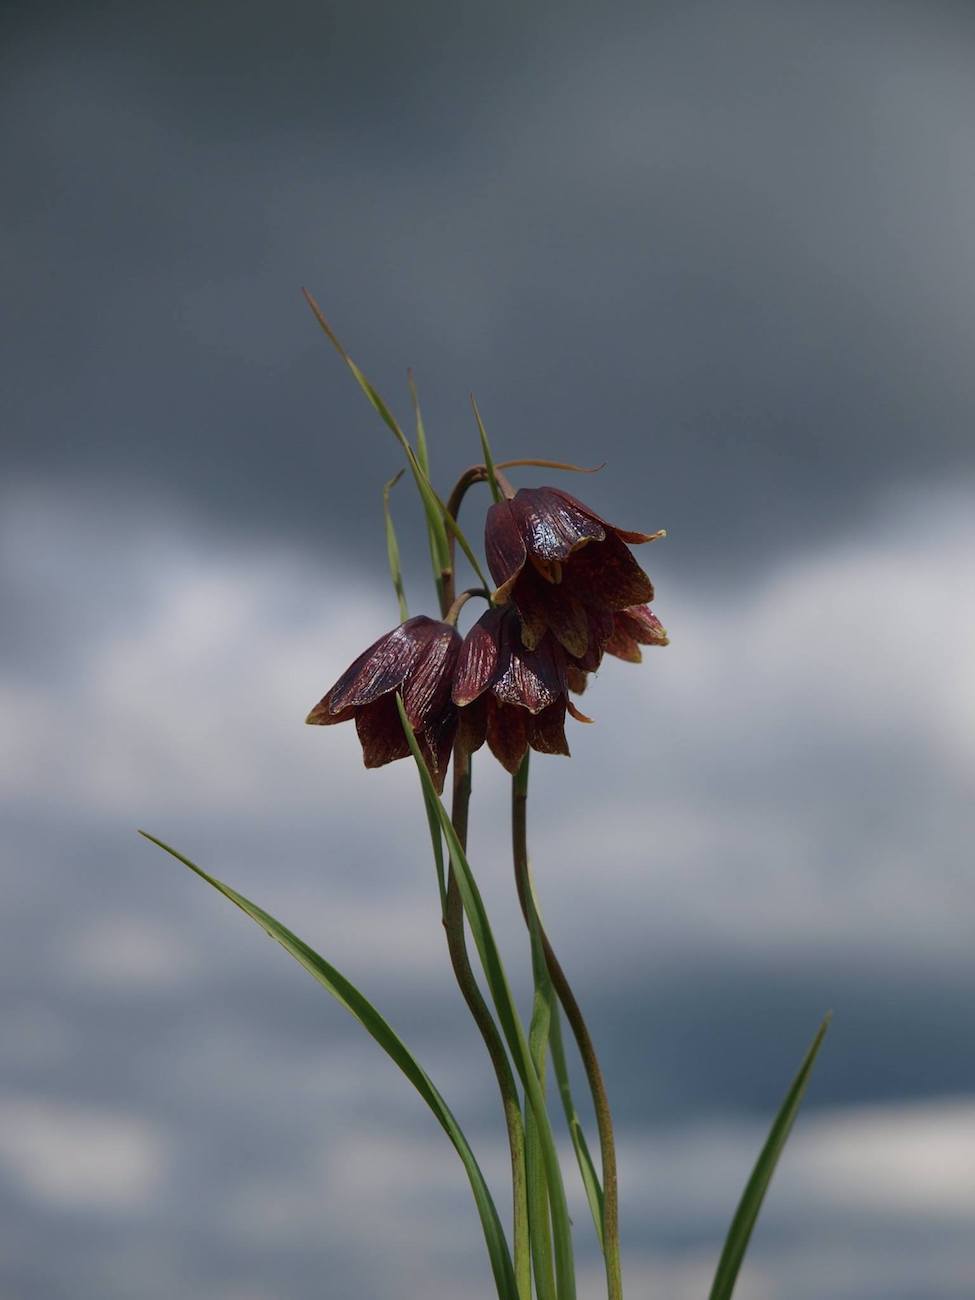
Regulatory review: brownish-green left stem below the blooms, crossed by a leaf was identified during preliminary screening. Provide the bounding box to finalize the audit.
[443,744,532,1300]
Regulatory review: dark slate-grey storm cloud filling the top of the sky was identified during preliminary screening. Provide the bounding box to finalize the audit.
[4,4,975,585]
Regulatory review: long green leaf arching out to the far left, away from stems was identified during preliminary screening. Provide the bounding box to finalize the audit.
[139,831,517,1300]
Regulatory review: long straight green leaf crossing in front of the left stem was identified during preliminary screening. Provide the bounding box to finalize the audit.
[397,696,576,1300]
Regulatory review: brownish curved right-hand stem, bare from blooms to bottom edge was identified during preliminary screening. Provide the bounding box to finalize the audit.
[511,757,623,1300]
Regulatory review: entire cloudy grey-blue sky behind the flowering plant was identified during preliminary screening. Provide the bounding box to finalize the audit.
[0,0,975,1300]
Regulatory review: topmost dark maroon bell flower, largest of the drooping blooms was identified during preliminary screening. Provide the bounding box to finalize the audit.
[485,488,663,672]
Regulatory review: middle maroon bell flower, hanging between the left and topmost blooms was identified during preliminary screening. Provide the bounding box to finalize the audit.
[454,605,589,774]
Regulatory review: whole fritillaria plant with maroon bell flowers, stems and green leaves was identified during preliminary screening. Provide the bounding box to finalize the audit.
[142,295,827,1300]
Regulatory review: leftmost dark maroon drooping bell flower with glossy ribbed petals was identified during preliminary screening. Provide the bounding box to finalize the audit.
[306,615,460,790]
